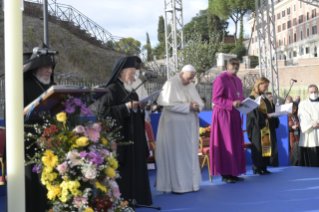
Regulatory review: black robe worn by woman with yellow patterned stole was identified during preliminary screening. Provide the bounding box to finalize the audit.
[246,96,280,168]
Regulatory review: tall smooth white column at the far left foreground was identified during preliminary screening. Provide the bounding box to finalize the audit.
[4,0,25,212]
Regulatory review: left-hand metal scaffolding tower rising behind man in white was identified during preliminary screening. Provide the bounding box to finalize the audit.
[164,0,184,79]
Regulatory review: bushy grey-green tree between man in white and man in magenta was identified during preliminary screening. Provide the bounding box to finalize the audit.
[179,31,225,85]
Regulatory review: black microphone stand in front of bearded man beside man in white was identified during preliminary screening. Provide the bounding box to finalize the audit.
[122,76,161,211]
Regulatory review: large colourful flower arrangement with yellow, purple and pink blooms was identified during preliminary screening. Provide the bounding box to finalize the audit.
[26,96,130,212]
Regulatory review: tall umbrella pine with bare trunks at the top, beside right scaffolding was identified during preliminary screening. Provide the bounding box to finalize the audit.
[208,0,255,46]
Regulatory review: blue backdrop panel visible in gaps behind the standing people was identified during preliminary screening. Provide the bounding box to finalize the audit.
[150,111,289,166]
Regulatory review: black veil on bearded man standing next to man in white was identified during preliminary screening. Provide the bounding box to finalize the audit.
[105,56,136,87]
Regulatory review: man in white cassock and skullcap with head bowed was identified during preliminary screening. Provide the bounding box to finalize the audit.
[156,65,204,193]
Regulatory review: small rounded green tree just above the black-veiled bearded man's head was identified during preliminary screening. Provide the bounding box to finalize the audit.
[114,37,141,55]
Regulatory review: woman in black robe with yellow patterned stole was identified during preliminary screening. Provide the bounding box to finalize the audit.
[246,77,279,175]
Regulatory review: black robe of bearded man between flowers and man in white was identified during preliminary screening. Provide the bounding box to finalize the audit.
[101,80,152,205]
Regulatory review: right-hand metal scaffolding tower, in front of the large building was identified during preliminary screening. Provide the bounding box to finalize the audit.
[255,0,280,105]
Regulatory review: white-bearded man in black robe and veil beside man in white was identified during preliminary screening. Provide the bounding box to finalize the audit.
[100,57,152,205]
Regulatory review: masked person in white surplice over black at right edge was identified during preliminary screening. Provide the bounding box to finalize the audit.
[298,85,319,167]
